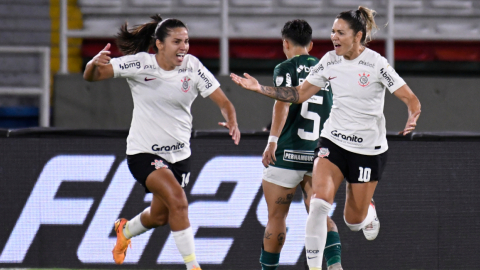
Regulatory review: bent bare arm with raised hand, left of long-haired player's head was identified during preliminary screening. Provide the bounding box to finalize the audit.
[83,43,113,82]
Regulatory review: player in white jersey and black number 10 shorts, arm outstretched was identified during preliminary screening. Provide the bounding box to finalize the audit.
[231,7,420,270]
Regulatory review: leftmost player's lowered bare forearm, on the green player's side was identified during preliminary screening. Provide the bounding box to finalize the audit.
[209,87,240,145]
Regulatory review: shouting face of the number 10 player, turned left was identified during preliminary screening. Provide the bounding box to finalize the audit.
[330,19,354,56]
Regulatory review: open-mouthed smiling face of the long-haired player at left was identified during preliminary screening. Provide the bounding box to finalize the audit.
[157,27,190,69]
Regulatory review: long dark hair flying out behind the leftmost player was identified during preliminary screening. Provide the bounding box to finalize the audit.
[115,14,188,55]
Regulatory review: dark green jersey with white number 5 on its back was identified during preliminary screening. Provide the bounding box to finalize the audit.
[273,55,332,171]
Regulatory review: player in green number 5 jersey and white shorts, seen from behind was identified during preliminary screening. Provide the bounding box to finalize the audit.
[260,20,342,270]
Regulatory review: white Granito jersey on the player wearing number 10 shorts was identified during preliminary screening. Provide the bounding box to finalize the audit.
[306,48,405,155]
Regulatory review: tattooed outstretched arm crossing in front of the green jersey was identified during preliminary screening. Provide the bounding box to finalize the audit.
[230,73,320,103]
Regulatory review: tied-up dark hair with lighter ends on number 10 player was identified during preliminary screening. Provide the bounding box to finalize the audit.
[337,6,378,46]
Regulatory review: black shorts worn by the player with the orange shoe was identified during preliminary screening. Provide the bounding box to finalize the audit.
[127,153,190,193]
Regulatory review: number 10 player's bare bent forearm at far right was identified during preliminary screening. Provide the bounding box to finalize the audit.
[393,84,421,136]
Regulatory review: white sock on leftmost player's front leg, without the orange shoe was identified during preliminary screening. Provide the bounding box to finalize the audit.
[172,227,200,270]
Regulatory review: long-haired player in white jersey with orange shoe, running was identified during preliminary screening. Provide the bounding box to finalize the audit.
[83,15,240,270]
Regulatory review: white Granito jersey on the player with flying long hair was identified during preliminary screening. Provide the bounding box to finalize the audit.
[110,52,220,163]
